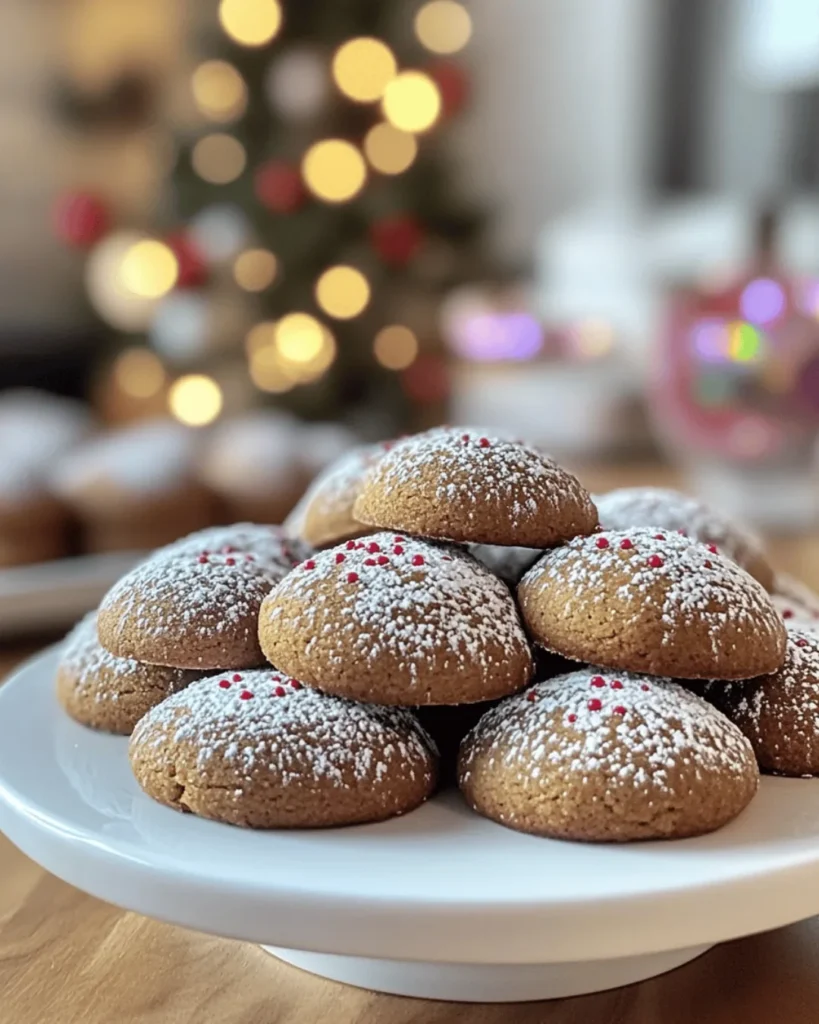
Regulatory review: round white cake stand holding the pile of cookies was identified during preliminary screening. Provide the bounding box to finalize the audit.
[0,652,819,1001]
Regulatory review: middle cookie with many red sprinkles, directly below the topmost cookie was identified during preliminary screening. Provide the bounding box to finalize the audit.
[259,534,532,706]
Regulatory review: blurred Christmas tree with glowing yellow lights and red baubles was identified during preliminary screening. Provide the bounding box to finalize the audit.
[58,0,486,426]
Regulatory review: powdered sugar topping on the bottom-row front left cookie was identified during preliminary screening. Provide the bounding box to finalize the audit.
[132,669,434,787]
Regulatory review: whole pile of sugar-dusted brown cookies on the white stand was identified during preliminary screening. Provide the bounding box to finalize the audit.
[54,428,819,841]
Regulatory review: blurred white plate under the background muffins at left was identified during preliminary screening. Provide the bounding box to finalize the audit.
[0,551,144,638]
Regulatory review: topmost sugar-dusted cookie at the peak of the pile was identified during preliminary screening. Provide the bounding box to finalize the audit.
[353,429,597,548]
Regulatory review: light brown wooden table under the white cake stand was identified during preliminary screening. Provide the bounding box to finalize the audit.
[0,539,819,1024]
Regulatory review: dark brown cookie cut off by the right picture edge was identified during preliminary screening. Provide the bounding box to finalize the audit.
[705,630,819,775]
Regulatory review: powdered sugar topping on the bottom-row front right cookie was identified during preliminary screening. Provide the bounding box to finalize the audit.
[464,668,752,793]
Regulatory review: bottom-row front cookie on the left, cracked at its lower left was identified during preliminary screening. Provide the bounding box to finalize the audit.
[130,669,436,828]
